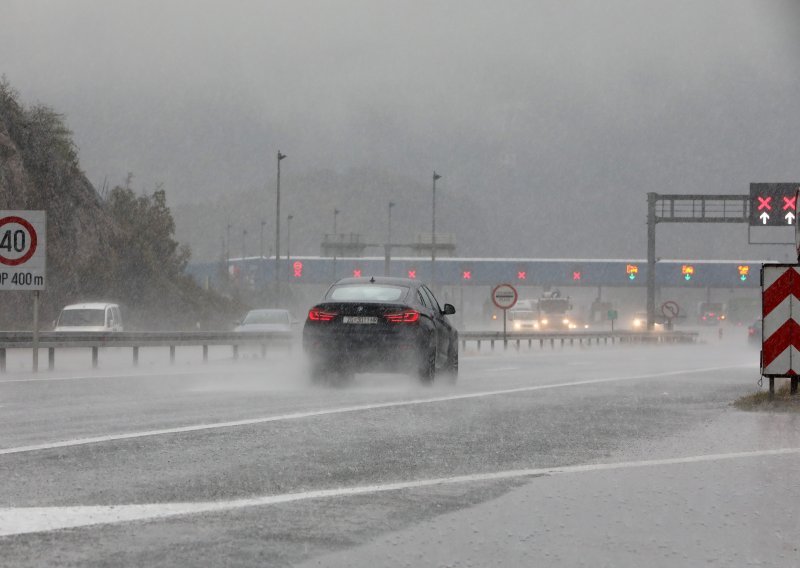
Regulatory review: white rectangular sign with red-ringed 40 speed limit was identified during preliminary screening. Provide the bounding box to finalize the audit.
[0,211,47,290]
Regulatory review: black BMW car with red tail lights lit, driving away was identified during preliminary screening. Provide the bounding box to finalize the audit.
[303,277,458,383]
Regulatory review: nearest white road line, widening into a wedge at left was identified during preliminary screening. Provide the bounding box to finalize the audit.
[0,448,800,537]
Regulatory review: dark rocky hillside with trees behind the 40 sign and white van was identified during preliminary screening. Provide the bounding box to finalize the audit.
[0,79,238,329]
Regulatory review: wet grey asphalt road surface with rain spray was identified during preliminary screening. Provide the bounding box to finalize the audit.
[0,333,800,566]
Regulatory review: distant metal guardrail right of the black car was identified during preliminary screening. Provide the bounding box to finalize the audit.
[458,331,699,351]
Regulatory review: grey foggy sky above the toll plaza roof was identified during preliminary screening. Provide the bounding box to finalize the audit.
[0,0,800,259]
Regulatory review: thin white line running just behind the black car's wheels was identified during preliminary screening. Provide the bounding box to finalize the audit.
[0,365,750,455]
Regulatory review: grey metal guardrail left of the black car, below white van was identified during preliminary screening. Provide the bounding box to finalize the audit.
[0,331,293,372]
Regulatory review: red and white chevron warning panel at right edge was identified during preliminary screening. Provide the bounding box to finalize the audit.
[761,264,800,377]
